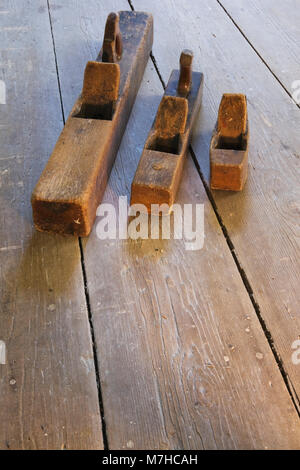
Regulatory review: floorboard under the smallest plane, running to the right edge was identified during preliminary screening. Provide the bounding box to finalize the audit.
[135,0,300,408]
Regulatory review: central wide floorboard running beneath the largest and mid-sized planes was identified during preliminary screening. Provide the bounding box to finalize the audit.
[51,0,300,449]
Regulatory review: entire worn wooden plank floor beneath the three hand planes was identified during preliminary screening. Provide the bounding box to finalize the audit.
[0,0,300,449]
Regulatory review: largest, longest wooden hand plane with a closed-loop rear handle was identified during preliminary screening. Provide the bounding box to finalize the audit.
[31,11,153,236]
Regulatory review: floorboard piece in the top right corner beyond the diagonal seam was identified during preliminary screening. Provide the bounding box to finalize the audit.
[219,0,300,97]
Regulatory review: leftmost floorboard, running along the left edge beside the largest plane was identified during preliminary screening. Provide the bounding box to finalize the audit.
[0,0,102,449]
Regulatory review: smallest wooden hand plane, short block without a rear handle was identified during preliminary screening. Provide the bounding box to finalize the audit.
[210,93,249,191]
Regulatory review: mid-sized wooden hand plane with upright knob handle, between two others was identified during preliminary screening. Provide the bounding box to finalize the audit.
[131,50,203,212]
